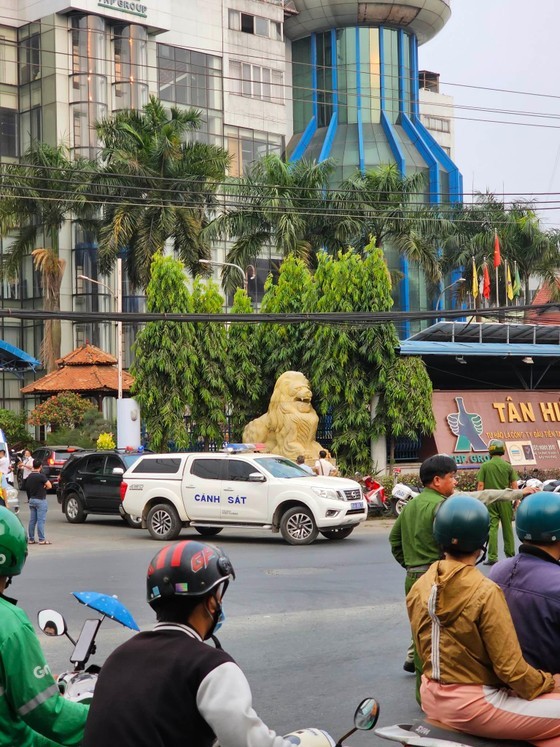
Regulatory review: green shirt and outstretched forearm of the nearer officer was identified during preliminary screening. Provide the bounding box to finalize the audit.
[389,488,523,568]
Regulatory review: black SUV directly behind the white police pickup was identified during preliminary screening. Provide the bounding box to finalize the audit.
[56,449,146,529]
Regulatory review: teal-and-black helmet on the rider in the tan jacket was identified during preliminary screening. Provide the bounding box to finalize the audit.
[433,495,490,554]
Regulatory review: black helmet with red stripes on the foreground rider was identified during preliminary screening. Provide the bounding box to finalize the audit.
[147,540,235,604]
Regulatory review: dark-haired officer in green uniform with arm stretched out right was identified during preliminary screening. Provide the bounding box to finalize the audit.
[389,454,535,702]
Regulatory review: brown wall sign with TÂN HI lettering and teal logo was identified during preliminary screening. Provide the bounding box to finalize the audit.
[433,390,560,469]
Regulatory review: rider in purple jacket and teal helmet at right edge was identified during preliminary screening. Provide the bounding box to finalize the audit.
[489,492,560,672]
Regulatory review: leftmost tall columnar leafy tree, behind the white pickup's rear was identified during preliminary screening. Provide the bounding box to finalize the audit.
[131,255,198,451]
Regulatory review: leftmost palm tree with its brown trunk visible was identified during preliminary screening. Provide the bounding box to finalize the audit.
[0,143,93,371]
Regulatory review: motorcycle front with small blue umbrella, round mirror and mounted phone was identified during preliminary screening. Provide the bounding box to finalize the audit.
[37,591,140,703]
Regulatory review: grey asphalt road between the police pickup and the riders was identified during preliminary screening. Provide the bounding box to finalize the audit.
[13,493,512,747]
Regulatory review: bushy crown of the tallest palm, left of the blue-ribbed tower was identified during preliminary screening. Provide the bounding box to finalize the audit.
[92,97,229,288]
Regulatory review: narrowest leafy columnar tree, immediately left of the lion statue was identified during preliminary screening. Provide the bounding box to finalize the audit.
[226,288,264,442]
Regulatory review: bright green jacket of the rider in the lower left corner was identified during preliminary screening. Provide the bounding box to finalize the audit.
[0,594,89,747]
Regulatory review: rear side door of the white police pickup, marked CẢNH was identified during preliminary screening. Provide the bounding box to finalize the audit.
[182,455,224,521]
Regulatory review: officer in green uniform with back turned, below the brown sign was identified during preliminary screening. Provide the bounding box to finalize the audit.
[477,439,518,565]
